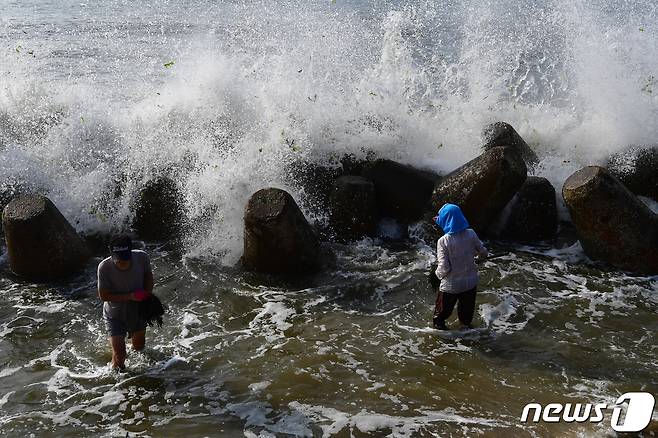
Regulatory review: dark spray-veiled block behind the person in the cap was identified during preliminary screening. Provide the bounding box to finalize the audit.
[132,177,184,240]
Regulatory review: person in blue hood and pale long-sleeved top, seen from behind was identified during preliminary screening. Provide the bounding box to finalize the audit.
[433,204,489,330]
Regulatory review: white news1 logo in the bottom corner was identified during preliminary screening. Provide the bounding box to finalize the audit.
[521,392,656,432]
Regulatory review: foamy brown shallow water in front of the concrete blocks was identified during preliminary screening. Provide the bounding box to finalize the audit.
[0,242,658,437]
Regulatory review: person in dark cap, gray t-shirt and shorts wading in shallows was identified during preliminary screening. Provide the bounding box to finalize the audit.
[98,235,153,370]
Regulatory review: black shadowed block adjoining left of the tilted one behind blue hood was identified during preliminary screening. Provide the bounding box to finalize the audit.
[362,160,440,223]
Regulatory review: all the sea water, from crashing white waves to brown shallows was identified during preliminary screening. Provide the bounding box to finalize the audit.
[0,0,658,438]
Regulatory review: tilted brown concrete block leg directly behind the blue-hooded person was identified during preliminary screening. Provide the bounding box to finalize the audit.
[427,147,527,233]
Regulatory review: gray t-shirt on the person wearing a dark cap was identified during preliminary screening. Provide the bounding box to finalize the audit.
[98,249,151,326]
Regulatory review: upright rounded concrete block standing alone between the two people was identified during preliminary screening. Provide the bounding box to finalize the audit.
[242,188,320,274]
